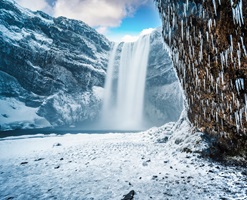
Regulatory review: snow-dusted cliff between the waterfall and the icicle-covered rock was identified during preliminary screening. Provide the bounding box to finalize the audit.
[144,28,183,126]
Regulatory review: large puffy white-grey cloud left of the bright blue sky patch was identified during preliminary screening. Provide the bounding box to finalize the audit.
[54,0,148,28]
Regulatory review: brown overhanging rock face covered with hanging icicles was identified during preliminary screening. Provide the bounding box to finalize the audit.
[156,0,247,157]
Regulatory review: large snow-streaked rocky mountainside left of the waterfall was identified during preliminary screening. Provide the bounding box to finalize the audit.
[0,0,111,130]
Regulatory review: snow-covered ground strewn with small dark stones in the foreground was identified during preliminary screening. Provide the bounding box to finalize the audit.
[0,118,247,200]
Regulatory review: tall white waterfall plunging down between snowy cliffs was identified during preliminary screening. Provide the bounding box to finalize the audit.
[102,34,150,130]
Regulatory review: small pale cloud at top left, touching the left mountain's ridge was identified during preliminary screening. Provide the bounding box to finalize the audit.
[15,0,53,15]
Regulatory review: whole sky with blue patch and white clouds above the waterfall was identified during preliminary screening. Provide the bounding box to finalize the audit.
[15,0,161,41]
